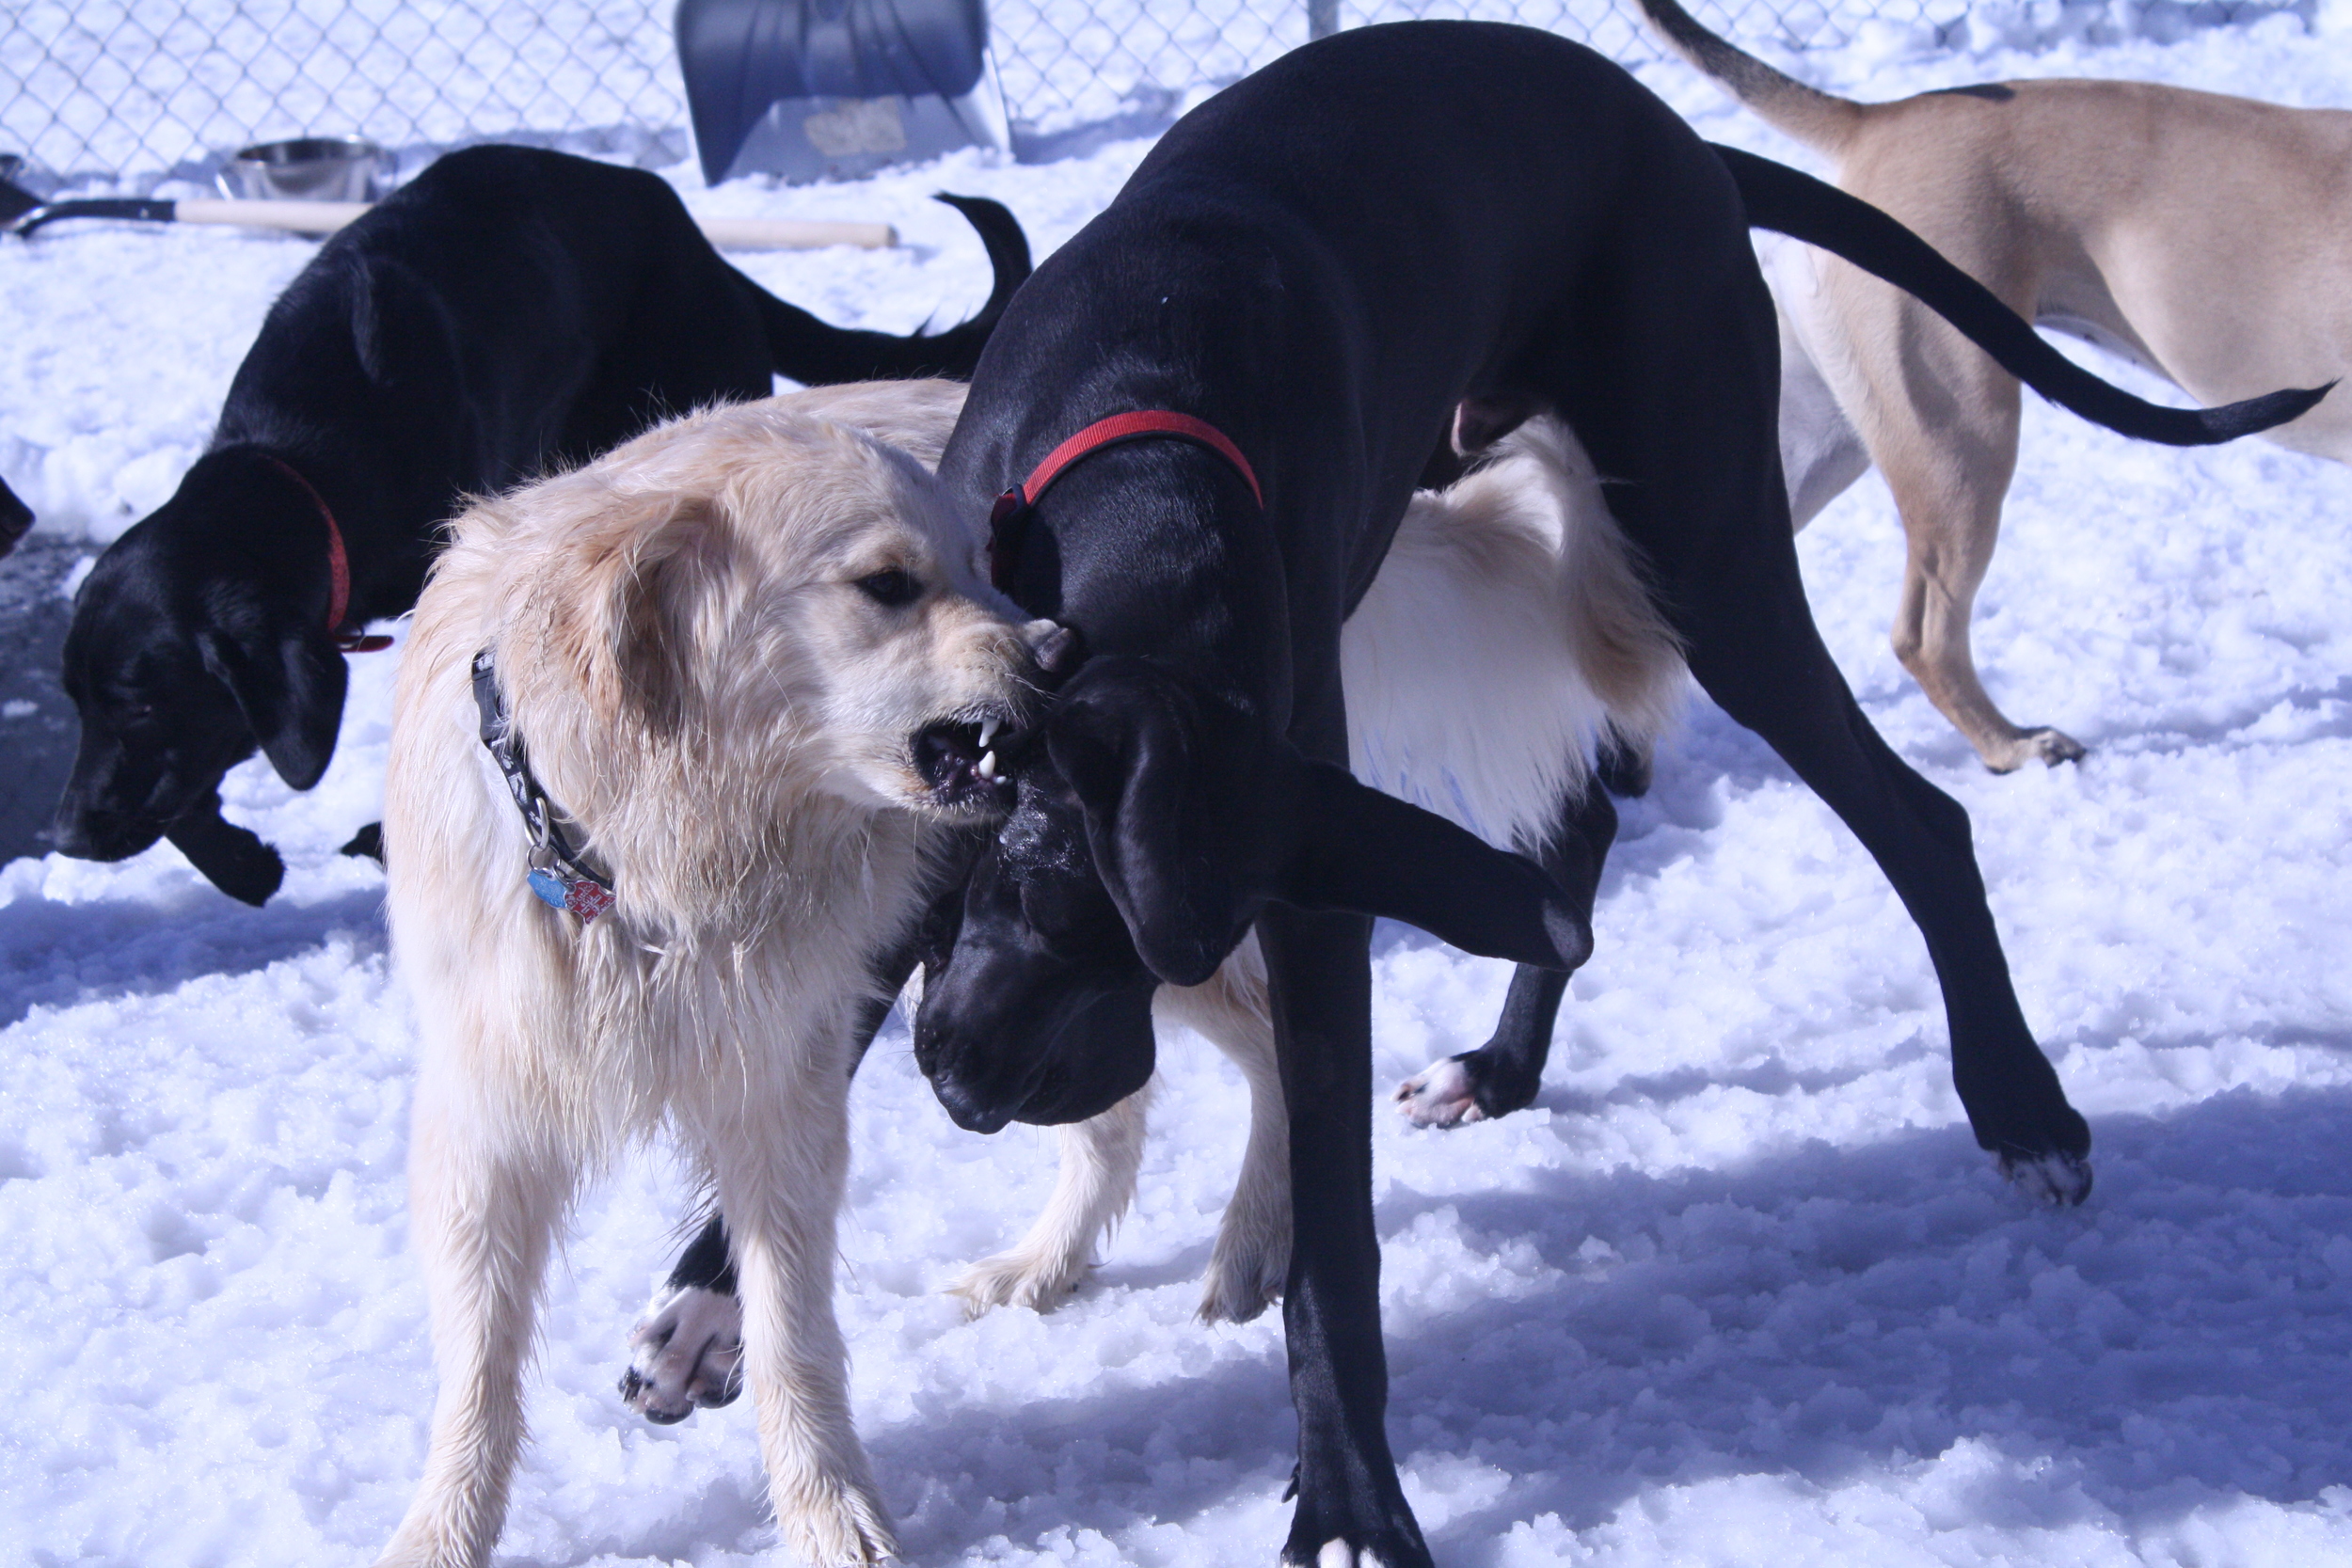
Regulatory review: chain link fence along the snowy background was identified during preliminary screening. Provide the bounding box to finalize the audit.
[0,0,2314,185]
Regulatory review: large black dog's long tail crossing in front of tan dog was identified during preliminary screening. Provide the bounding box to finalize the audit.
[1715,146,2336,447]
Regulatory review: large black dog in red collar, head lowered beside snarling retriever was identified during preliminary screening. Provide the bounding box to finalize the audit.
[649,24,2317,1568]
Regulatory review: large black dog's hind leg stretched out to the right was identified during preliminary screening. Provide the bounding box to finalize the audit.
[1555,171,2091,1201]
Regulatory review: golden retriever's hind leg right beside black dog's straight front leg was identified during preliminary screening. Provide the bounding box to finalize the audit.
[1157,936,1292,1323]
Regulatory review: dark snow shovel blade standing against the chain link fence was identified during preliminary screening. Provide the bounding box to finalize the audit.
[675,0,1011,185]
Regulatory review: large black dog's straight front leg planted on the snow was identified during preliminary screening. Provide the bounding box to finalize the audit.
[1259,905,1430,1568]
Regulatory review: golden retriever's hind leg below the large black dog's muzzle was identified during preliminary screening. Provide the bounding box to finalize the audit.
[950,1084,1152,1317]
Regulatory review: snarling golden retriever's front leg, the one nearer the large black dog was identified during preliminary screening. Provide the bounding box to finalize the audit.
[690,1039,897,1568]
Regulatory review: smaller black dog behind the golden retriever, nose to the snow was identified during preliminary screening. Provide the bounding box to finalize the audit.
[56,146,1028,903]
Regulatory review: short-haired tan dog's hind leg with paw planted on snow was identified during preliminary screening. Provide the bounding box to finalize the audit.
[1823,256,2082,773]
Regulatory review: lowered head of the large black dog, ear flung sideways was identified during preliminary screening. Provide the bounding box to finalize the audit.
[915,658,1593,1133]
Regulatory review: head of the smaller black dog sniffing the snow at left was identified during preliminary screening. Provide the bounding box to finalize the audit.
[56,451,346,895]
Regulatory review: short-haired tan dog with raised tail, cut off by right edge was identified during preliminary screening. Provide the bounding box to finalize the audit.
[1642,0,2352,773]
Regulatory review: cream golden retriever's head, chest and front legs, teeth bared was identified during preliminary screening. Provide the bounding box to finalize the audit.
[384,383,1054,1568]
